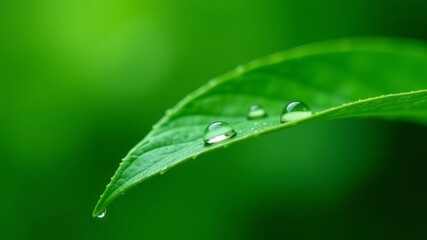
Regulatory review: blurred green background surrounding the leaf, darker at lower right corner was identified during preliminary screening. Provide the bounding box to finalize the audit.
[0,0,427,240]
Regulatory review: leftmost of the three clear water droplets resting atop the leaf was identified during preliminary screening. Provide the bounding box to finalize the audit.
[203,121,236,144]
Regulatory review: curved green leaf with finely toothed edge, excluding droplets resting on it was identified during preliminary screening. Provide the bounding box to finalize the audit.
[93,38,427,216]
